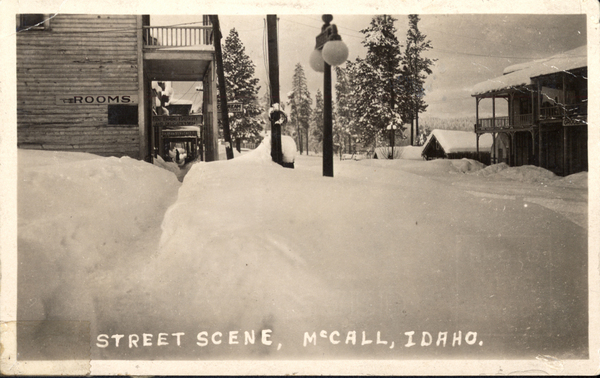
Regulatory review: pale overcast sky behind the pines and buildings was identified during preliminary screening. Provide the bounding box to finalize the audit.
[151,14,587,118]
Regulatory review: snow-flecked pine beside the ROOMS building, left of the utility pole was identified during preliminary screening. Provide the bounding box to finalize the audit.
[223,28,264,151]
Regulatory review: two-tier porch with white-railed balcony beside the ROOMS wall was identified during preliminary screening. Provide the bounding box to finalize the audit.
[143,20,219,161]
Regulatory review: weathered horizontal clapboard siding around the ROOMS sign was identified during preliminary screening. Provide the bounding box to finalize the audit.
[17,14,141,158]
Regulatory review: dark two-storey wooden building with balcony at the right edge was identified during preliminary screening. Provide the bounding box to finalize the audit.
[472,46,588,176]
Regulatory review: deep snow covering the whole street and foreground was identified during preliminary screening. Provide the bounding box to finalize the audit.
[18,140,588,359]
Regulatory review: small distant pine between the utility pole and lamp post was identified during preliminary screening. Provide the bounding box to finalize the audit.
[287,63,312,154]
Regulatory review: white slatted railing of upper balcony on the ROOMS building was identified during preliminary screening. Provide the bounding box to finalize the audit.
[144,25,212,49]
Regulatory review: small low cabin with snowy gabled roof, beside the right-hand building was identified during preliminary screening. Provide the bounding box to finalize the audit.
[421,129,493,165]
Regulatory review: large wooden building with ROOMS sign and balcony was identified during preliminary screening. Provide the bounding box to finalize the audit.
[16,13,218,161]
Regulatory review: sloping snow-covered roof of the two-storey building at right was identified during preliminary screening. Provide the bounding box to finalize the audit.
[472,45,587,96]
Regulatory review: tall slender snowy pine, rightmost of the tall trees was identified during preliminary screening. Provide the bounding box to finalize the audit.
[402,14,435,144]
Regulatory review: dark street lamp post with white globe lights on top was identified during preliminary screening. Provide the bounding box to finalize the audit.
[310,14,348,177]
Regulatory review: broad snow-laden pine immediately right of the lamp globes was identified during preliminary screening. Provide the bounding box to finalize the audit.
[350,15,405,148]
